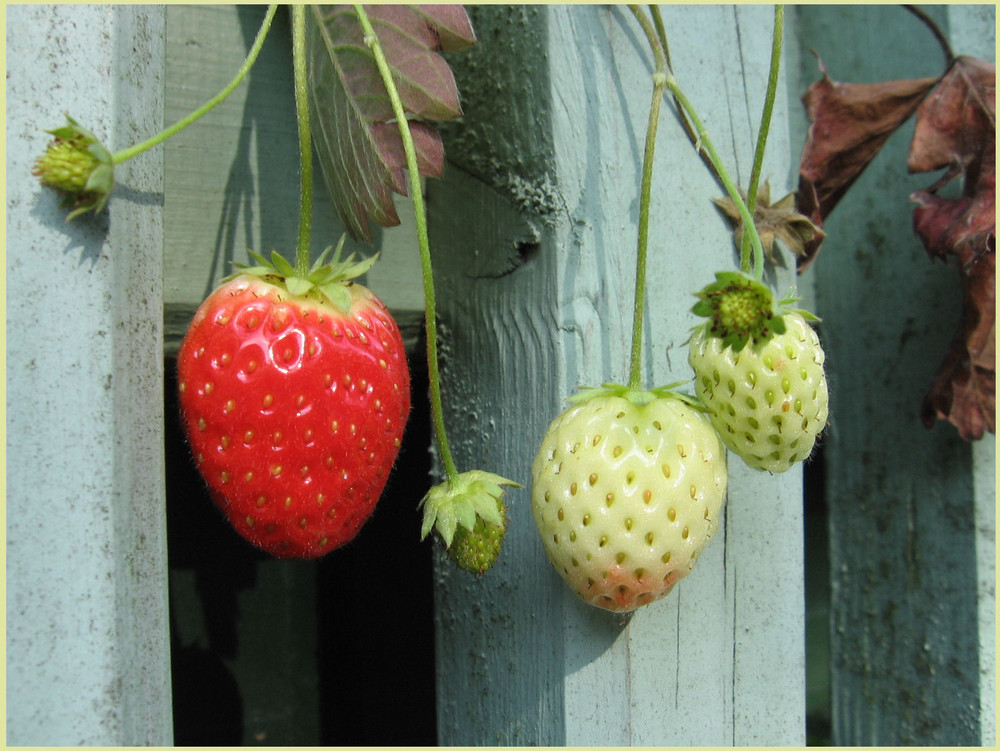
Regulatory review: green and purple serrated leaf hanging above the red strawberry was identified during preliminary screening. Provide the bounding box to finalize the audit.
[306,5,475,241]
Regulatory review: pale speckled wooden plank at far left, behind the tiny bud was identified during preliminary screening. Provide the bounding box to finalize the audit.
[6,5,172,746]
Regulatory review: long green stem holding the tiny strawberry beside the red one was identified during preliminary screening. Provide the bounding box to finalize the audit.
[354,5,458,483]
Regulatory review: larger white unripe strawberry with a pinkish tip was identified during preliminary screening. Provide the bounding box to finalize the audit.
[532,385,727,612]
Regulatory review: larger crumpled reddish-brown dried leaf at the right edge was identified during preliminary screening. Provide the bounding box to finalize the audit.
[908,57,996,440]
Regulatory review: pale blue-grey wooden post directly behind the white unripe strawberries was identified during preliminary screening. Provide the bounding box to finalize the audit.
[429,6,804,745]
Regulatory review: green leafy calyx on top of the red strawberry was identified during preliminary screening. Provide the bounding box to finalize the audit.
[227,237,378,313]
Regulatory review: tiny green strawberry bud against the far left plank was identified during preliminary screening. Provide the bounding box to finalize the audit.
[31,115,115,220]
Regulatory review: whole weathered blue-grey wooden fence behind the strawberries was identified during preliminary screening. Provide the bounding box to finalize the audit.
[6,5,996,745]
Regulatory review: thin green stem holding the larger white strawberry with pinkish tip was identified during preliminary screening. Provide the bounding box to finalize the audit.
[628,5,667,390]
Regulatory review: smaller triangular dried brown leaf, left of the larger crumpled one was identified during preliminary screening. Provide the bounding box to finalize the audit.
[795,60,938,271]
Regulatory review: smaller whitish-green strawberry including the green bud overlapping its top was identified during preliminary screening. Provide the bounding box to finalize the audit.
[688,273,829,472]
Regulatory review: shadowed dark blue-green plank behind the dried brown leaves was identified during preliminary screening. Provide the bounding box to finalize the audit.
[797,6,992,745]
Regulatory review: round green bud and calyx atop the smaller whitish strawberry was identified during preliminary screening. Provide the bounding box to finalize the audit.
[691,271,819,352]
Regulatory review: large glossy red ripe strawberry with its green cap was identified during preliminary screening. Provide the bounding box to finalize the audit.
[177,248,410,558]
